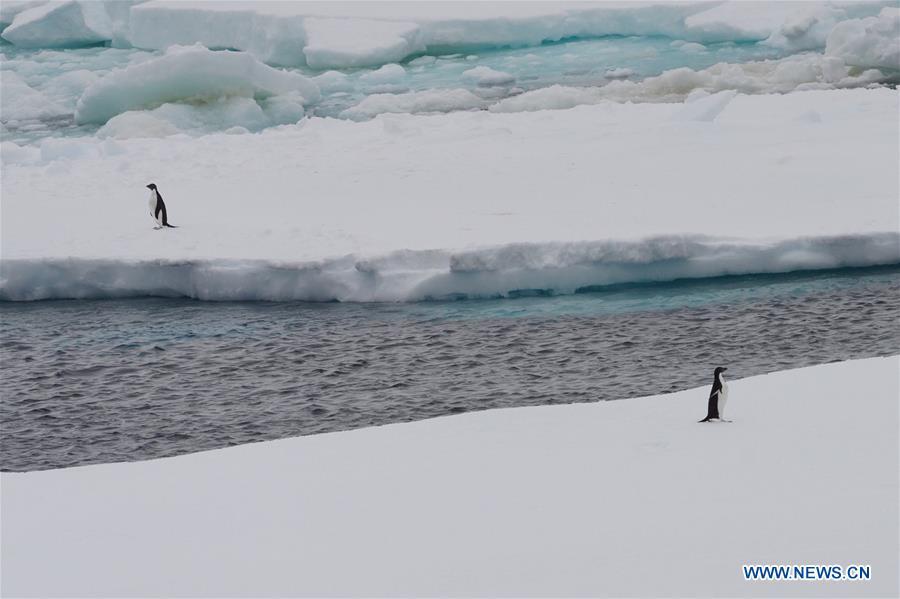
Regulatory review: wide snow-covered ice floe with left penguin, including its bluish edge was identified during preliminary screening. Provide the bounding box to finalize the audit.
[0,89,900,301]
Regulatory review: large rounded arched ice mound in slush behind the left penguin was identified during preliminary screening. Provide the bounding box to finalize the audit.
[75,46,319,123]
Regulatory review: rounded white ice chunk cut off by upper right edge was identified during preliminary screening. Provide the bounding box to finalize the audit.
[825,7,900,70]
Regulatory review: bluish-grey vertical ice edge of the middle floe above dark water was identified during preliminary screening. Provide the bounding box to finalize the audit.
[0,233,900,302]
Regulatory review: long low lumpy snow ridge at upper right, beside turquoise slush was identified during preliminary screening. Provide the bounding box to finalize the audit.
[489,54,886,112]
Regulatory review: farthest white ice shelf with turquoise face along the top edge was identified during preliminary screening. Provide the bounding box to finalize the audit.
[3,0,895,68]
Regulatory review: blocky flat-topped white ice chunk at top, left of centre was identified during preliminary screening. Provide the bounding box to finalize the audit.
[303,18,425,69]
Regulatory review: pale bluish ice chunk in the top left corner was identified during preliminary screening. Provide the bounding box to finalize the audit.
[2,0,112,48]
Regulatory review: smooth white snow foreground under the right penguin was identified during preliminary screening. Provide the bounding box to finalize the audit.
[0,357,900,597]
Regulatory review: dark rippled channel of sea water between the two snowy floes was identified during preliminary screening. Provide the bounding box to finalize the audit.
[0,266,900,471]
